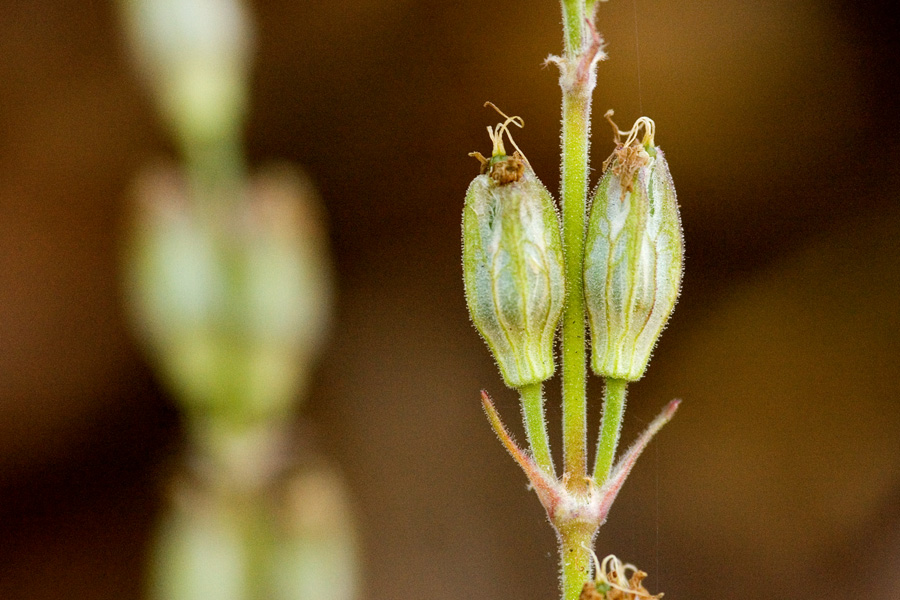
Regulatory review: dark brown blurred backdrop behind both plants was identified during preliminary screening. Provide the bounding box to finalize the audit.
[0,0,900,600]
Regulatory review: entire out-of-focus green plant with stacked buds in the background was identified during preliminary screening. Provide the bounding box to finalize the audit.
[121,0,356,600]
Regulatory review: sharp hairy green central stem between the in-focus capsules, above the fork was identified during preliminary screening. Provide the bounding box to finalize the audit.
[560,0,593,492]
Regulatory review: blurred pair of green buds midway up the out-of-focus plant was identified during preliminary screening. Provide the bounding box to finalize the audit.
[124,162,331,422]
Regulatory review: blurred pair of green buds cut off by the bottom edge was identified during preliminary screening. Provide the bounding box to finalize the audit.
[150,430,358,600]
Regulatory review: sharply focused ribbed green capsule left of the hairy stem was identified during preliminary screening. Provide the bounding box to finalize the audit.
[463,106,565,388]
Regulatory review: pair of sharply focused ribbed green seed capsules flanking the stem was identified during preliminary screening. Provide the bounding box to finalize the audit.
[463,107,684,388]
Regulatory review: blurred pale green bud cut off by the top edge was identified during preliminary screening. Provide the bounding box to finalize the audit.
[120,0,252,145]
